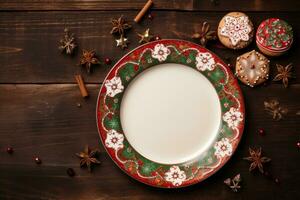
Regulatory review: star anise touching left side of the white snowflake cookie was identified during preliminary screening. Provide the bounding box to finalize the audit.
[192,22,217,46]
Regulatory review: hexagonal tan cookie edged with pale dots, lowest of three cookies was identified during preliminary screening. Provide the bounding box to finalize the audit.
[235,50,270,87]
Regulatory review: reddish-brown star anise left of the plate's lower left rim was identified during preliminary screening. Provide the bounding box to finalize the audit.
[76,146,100,172]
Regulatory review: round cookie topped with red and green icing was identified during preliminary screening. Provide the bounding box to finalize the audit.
[256,18,293,56]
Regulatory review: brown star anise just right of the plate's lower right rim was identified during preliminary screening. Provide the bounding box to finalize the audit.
[244,148,271,174]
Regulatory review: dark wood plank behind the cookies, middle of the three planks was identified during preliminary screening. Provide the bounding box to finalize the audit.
[0,11,300,83]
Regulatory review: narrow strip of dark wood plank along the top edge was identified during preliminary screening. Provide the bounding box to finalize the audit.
[0,0,300,11]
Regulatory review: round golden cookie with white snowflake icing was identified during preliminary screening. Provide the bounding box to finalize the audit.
[218,12,254,49]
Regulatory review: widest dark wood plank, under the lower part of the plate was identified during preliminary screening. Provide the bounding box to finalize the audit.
[0,84,300,200]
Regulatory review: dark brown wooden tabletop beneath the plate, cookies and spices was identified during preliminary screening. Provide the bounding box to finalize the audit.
[0,0,300,200]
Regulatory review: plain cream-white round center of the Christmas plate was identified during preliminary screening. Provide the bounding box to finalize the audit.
[120,63,221,164]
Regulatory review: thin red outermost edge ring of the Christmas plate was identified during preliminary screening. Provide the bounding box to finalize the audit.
[96,39,246,188]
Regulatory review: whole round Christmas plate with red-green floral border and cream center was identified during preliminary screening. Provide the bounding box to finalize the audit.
[97,40,245,188]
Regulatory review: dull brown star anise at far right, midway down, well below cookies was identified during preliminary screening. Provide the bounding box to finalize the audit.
[264,99,288,121]
